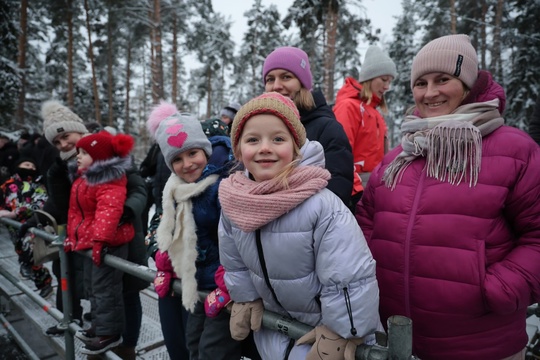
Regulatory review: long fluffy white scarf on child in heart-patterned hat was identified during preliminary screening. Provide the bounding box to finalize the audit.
[156,174,219,312]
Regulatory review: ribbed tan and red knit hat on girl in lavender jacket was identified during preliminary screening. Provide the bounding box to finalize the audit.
[231,92,306,155]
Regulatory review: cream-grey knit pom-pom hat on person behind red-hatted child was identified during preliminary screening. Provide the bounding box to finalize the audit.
[41,100,88,144]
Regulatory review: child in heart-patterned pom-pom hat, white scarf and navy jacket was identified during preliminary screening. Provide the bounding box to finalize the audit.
[146,102,242,360]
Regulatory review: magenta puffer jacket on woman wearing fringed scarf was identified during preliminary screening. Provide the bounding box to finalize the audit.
[356,126,540,360]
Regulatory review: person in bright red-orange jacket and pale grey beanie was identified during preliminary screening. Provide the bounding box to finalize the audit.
[333,45,397,210]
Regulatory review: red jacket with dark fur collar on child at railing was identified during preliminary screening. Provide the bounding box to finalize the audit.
[64,158,135,251]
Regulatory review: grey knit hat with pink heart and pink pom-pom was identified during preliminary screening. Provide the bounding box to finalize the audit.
[146,101,212,172]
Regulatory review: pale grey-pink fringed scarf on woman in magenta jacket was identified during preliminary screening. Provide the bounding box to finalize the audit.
[383,99,504,190]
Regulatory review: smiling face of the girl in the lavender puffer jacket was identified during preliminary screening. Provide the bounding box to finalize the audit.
[239,114,294,182]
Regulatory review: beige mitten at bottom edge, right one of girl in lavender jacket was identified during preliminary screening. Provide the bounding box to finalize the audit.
[296,325,364,360]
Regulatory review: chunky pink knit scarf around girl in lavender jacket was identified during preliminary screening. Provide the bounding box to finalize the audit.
[219,166,330,232]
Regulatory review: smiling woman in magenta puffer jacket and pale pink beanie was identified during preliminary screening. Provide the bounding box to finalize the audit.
[356,35,540,360]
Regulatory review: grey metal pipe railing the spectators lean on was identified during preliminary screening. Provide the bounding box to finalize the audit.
[0,218,415,360]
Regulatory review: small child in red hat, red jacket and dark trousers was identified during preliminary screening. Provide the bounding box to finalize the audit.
[64,131,135,355]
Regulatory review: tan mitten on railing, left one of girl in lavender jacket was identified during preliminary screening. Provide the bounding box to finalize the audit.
[229,299,264,341]
